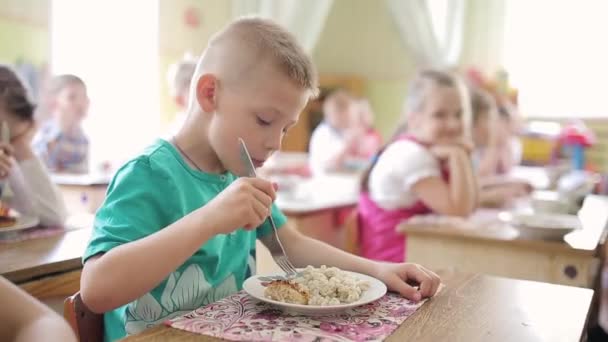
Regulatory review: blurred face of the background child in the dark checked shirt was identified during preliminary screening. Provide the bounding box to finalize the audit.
[55,84,89,123]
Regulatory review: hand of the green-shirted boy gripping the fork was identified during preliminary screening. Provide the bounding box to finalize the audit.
[203,177,276,234]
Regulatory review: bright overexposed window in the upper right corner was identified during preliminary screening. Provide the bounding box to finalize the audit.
[504,0,608,118]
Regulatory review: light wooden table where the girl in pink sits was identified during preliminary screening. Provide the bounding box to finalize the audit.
[398,195,608,288]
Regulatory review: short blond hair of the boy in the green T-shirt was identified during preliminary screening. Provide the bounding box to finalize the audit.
[189,17,318,110]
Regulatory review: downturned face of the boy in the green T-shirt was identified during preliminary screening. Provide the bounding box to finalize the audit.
[209,66,308,175]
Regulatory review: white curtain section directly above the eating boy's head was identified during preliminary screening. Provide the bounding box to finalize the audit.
[232,0,333,53]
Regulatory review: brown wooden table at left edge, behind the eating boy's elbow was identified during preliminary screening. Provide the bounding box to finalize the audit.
[0,228,92,299]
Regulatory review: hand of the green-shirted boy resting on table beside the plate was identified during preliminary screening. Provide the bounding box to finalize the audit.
[375,262,441,302]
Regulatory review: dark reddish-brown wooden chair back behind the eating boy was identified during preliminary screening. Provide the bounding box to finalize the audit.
[63,292,103,342]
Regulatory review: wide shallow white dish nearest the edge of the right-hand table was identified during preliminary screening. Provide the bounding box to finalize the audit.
[507,213,581,240]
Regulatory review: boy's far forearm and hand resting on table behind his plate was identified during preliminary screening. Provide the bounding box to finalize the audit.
[279,223,441,301]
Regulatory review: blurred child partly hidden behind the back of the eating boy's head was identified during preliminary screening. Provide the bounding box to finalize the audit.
[168,58,196,136]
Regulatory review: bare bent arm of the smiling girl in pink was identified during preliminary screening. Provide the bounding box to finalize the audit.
[412,146,478,216]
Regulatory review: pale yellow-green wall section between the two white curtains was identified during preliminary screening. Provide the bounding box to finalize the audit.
[313,0,415,137]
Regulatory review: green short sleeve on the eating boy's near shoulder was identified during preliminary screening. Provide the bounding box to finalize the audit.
[83,159,174,262]
